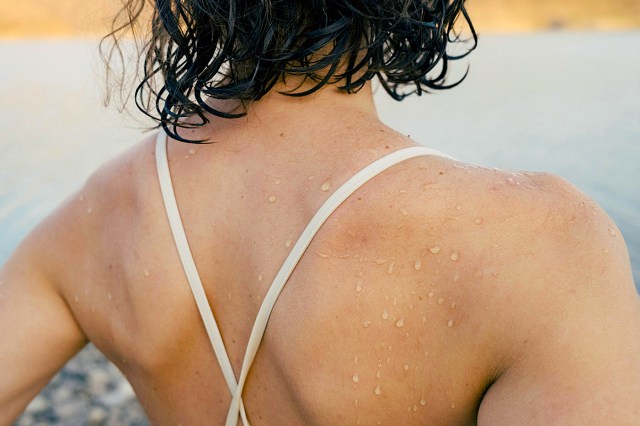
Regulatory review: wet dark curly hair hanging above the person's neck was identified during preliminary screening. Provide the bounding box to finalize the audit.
[103,0,477,141]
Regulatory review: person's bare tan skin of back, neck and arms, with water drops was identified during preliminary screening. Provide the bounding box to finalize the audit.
[0,80,640,425]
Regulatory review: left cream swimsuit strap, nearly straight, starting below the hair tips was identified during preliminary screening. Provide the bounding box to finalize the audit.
[156,131,249,426]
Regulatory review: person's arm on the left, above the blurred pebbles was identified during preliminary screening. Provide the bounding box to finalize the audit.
[0,220,86,425]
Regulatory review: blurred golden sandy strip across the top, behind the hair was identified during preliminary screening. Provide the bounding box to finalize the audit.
[0,0,640,38]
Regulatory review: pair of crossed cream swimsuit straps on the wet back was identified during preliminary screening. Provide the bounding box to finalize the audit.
[156,132,449,426]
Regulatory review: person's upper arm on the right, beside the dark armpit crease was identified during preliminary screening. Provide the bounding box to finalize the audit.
[478,175,640,425]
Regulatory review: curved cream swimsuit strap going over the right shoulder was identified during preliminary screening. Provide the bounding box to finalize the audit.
[225,147,450,426]
